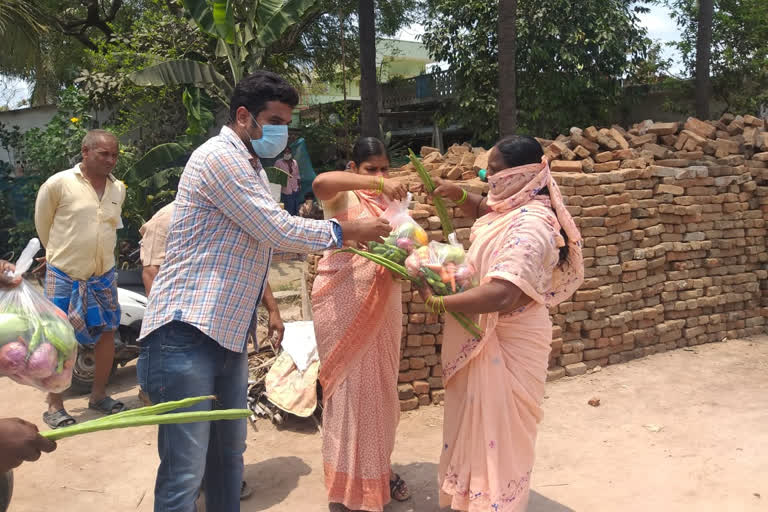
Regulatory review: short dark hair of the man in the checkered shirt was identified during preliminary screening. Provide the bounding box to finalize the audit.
[229,71,299,122]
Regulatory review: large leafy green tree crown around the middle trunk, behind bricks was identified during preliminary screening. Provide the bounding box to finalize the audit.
[423,0,648,144]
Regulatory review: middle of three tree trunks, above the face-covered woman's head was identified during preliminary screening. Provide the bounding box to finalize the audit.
[499,0,517,137]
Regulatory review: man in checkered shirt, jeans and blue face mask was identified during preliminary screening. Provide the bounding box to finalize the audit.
[137,71,390,512]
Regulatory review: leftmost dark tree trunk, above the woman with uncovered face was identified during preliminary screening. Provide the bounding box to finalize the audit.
[358,0,381,137]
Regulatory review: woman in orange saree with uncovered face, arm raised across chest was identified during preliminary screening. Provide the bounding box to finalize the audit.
[312,138,408,511]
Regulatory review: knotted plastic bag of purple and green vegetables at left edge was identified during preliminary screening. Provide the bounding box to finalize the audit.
[0,238,77,393]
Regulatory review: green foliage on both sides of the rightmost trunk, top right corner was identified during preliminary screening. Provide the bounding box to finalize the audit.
[667,0,768,113]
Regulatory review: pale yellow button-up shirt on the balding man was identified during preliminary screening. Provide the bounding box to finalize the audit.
[35,164,125,280]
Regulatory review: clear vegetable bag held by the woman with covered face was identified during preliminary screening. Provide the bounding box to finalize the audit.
[405,233,475,295]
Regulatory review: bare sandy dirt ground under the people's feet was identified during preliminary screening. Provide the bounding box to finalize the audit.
[0,337,768,512]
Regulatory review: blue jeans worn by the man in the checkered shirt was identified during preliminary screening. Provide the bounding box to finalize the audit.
[137,322,248,512]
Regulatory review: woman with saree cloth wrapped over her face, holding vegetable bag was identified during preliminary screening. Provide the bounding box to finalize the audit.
[420,136,584,512]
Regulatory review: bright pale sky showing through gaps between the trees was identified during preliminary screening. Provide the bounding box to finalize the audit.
[0,6,682,108]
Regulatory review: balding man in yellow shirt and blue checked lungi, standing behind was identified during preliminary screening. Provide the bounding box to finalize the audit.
[35,130,125,428]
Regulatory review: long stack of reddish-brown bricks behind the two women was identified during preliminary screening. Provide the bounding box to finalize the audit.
[307,114,768,410]
